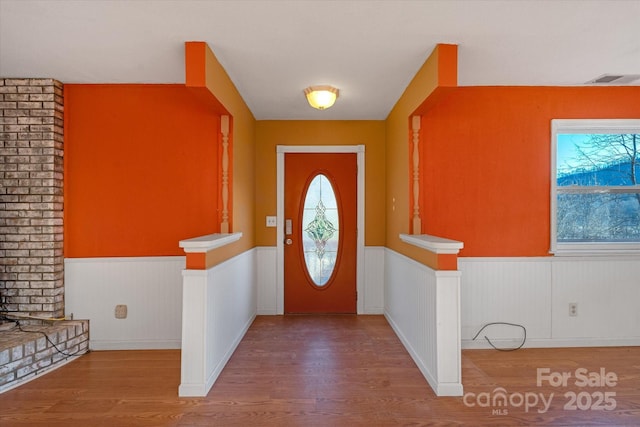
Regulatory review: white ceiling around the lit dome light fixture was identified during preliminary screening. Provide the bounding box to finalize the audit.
[0,0,640,120]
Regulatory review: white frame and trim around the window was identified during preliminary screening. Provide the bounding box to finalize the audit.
[549,119,640,255]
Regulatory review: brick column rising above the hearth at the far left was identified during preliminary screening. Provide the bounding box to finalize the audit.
[0,78,64,317]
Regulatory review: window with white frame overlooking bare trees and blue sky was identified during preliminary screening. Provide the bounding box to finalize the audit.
[551,120,640,254]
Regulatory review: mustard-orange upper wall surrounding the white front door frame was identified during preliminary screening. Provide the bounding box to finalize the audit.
[255,120,385,246]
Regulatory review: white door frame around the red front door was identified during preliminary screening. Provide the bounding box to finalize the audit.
[276,145,364,314]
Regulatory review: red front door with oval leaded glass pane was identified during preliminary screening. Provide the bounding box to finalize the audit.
[284,153,357,313]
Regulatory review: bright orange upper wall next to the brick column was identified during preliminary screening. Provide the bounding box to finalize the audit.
[64,84,219,257]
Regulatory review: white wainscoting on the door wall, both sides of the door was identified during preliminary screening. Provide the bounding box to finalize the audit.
[256,246,385,315]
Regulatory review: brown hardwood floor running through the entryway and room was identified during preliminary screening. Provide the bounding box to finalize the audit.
[0,316,640,427]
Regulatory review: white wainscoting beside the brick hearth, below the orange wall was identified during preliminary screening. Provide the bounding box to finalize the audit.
[64,256,185,350]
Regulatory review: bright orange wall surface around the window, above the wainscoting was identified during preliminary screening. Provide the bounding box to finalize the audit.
[421,87,640,256]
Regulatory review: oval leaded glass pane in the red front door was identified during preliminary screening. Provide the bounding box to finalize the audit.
[302,174,340,287]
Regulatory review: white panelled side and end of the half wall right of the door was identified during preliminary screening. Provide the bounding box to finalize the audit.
[384,250,463,396]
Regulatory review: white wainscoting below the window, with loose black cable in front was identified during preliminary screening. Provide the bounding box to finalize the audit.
[458,256,640,348]
